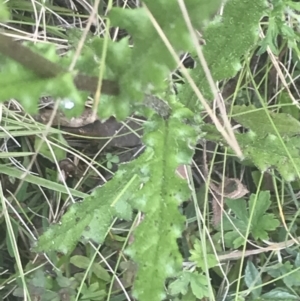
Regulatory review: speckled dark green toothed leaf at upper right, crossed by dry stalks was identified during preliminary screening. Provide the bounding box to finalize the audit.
[179,0,267,110]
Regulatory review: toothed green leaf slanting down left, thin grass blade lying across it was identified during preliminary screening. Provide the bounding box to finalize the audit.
[35,165,142,253]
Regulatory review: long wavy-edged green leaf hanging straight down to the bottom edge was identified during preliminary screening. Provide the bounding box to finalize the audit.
[127,107,197,301]
